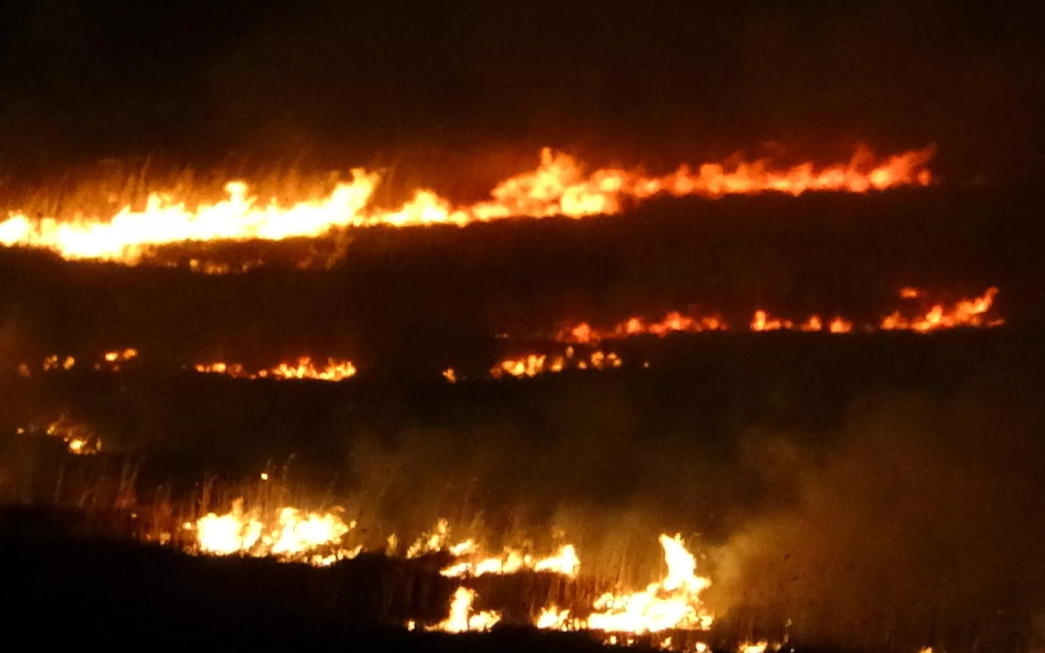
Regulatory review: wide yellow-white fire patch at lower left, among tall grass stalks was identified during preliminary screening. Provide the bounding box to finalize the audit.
[187,499,361,566]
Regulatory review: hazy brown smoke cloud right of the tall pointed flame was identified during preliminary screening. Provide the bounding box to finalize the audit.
[707,383,1045,650]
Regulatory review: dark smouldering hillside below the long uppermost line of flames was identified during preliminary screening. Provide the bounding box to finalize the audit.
[0,176,1045,653]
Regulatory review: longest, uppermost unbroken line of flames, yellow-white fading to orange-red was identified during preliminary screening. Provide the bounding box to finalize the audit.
[0,147,933,265]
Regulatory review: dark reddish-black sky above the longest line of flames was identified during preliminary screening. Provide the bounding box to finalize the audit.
[0,0,1045,180]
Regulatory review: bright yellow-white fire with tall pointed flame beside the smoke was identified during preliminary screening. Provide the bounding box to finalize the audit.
[586,535,714,634]
